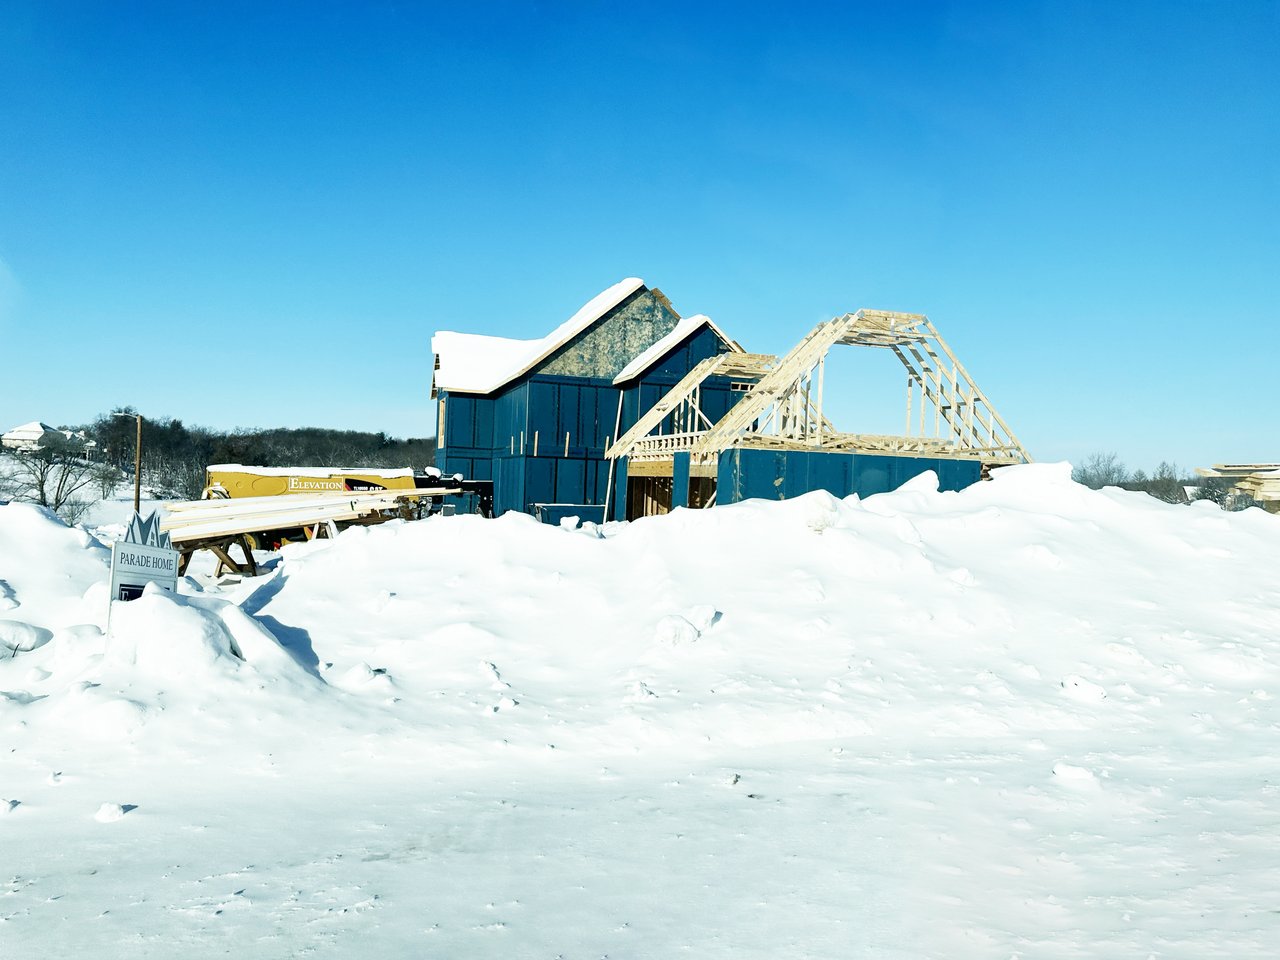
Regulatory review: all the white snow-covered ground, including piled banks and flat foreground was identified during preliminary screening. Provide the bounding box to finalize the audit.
[0,465,1280,959]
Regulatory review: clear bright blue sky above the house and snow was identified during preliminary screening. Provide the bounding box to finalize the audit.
[0,0,1280,470]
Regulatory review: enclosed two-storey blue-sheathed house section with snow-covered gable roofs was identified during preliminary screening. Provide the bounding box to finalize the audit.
[431,278,742,520]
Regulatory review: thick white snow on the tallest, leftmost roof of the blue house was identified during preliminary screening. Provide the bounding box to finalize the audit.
[431,276,644,393]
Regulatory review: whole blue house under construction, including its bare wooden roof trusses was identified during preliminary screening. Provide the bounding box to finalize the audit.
[433,278,1029,521]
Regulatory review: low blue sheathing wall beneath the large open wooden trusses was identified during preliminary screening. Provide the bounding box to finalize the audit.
[716,449,982,503]
